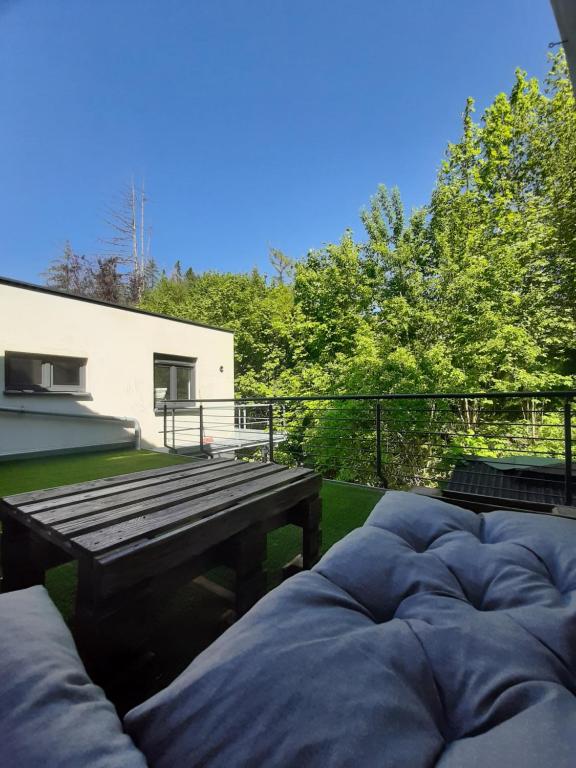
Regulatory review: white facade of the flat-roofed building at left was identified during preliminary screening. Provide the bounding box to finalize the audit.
[0,279,234,457]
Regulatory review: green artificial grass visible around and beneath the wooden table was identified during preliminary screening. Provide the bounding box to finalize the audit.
[0,450,381,619]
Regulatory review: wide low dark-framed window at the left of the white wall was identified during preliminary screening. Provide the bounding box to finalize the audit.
[4,352,86,393]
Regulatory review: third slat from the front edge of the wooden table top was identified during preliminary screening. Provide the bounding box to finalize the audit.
[29,462,262,526]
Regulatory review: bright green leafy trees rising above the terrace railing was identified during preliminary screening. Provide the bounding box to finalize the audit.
[142,54,576,408]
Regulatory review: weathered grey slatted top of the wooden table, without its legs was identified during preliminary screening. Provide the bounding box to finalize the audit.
[2,459,321,561]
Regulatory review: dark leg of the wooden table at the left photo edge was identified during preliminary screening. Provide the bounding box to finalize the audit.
[0,517,44,592]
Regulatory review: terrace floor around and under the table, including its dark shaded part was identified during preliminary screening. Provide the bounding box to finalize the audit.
[0,450,388,710]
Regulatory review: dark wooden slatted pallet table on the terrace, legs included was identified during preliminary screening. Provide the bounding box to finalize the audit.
[0,459,321,676]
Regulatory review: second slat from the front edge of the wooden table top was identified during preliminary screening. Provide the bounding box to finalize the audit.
[51,465,279,537]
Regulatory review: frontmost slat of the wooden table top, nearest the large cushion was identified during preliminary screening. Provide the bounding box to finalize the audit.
[71,465,318,553]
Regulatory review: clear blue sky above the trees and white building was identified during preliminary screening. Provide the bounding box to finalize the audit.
[0,0,558,282]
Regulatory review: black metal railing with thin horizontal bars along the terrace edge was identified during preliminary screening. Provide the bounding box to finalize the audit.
[164,391,576,507]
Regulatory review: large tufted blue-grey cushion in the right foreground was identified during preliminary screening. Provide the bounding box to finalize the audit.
[126,492,576,768]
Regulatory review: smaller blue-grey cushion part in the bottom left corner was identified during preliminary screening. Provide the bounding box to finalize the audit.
[0,587,146,768]
